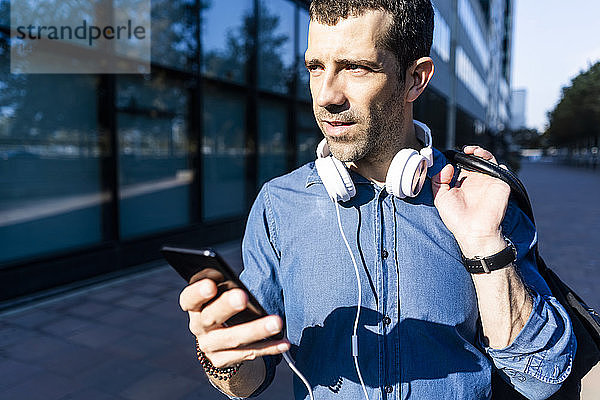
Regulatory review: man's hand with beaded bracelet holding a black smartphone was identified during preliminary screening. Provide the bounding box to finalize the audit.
[162,247,290,397]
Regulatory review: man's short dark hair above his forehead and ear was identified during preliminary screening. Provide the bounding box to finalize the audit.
[310,0,433,80]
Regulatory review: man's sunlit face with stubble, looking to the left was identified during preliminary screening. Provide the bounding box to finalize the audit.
[305,11,406,161]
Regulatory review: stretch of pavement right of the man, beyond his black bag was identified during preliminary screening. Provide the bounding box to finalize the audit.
[519,163,600,400]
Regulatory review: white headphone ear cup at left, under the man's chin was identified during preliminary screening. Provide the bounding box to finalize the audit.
[315,156,356,201]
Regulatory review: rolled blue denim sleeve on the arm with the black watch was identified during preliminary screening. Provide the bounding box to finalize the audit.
[479,203,577,399]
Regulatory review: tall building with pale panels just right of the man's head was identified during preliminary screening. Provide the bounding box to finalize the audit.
[432,0,513,145]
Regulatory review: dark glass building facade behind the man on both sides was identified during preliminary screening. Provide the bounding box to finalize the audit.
[0,0,510,304]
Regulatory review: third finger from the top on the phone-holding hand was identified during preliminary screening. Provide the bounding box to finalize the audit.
[198,315,283,352]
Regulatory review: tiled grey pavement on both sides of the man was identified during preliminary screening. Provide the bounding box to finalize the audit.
[0,160,600,400]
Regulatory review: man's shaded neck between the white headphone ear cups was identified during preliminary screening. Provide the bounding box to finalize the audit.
[346,120,423,186]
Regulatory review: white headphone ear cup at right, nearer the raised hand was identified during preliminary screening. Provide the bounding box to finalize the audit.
[385,149,427,199]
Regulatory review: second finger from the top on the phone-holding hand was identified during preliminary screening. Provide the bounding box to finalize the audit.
[197,289,248,332]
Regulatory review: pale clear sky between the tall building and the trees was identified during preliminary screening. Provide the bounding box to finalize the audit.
[512,0,600,131]
